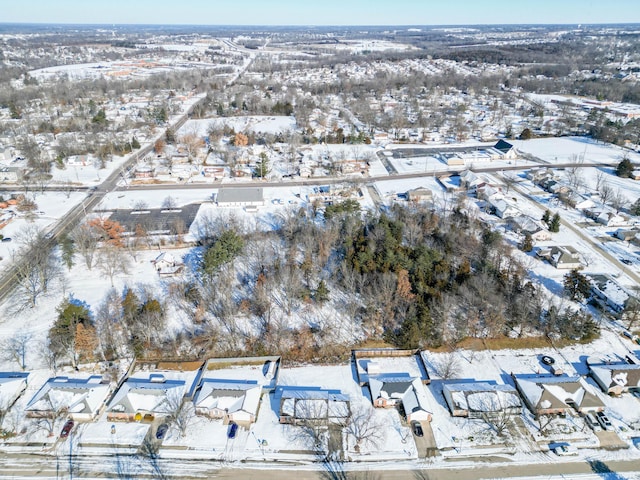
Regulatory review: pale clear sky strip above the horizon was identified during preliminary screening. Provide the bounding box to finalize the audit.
[0,0,640,25]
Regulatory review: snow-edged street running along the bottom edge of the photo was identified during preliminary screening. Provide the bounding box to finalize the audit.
[0,452,640,480]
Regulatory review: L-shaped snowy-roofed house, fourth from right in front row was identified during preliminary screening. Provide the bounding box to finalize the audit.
[369,374,431,422]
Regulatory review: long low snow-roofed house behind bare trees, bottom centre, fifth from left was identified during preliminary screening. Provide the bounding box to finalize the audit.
[275,386,351,425]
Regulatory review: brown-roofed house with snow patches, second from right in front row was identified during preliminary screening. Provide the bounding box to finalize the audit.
[512,374,604,416]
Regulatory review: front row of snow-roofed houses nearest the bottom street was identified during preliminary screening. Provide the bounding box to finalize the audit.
[5,349,640,436]
